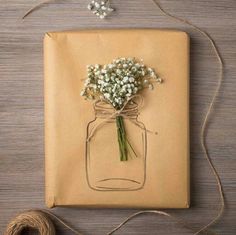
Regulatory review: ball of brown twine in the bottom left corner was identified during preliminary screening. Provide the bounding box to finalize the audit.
[4,211,56,235]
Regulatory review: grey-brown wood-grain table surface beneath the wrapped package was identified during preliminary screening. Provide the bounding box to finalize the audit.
[0,0,236,235]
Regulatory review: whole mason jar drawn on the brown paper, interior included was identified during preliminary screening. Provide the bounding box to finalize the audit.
[86,101,147,191]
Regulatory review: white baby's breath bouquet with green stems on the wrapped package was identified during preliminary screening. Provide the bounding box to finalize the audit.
[81,58,162,161]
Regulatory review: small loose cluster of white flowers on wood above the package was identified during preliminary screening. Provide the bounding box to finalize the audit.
[88,0,114,19]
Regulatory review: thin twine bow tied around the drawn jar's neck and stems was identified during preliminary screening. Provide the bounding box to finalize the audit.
[86,95,158,142]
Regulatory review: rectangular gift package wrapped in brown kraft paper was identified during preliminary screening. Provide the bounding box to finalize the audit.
[44,29,189,208]
